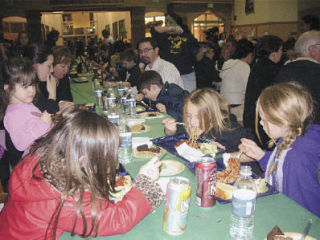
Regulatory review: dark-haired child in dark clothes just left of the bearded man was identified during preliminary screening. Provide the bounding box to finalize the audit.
[120,49,140,87]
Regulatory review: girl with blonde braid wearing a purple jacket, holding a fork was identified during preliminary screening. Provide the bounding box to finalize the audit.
[239,82,320,216]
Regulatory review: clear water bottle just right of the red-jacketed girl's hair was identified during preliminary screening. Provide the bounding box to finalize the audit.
[118,117,132,164]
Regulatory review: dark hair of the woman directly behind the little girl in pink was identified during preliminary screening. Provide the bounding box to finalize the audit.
[24,43,53,64]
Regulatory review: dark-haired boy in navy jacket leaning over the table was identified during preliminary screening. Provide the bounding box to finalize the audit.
[139,70,189,121]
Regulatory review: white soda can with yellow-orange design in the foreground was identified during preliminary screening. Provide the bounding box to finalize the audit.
[163,177,191,235]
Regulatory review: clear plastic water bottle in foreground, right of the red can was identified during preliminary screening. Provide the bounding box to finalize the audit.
[230,166,257,240]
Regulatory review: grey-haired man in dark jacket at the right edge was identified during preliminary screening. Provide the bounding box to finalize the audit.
[276,31,320,124]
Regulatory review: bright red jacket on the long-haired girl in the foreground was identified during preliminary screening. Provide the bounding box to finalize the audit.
[0,156,151,240]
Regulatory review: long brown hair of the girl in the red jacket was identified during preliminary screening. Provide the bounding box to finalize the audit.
[30,111,119,239]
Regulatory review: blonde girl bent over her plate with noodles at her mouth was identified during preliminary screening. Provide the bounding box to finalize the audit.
[163,88,251,152]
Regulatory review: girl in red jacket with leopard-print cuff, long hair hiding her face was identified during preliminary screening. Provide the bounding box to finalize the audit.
[0,111,163,239]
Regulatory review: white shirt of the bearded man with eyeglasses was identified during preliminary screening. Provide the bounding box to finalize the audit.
[145,57,183,88]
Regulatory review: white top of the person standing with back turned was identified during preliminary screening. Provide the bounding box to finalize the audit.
[220,59,250,104]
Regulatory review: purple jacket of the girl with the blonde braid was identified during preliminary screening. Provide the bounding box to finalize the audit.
[259,124,320,217]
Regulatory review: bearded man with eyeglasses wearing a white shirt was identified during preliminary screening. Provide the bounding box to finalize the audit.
[138,38,183,88]
